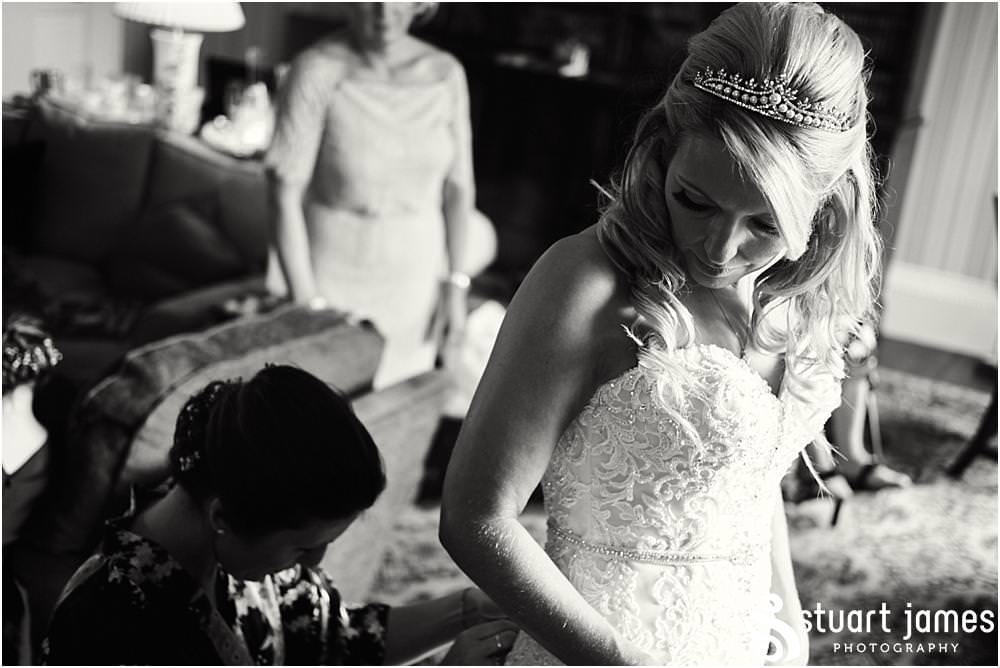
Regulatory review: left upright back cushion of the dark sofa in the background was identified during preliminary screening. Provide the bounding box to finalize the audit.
[30,101,155,262]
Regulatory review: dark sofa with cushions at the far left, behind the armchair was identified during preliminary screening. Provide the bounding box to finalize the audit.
[3,99,278,388]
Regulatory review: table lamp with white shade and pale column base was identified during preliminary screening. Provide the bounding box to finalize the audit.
[114,2,244,132]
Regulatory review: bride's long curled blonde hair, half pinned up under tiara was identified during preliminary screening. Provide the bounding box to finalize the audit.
[598,3,881,444]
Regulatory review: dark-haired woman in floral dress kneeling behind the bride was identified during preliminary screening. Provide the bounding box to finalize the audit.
[46,366,515,665]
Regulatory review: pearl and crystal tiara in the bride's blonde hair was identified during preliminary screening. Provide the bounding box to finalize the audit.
[694,67,851,132]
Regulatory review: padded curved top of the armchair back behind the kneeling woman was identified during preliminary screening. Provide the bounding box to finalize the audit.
[26,304,383,552]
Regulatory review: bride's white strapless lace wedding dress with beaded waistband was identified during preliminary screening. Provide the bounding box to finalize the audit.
[507,344,840,665]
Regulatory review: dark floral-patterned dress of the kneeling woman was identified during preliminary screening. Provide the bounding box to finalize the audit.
[43,504,389,666]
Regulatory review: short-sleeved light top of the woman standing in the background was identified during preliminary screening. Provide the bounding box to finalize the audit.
[266,40,471,216]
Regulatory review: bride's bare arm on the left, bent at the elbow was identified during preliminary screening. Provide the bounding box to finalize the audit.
[441,238,641,665]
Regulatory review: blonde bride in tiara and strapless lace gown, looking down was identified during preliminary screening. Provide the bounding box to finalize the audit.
[441,3,880,665]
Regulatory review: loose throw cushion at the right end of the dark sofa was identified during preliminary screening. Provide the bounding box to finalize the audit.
[105,191,246,301]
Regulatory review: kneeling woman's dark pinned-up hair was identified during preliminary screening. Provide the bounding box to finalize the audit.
[170,366,385,534]
